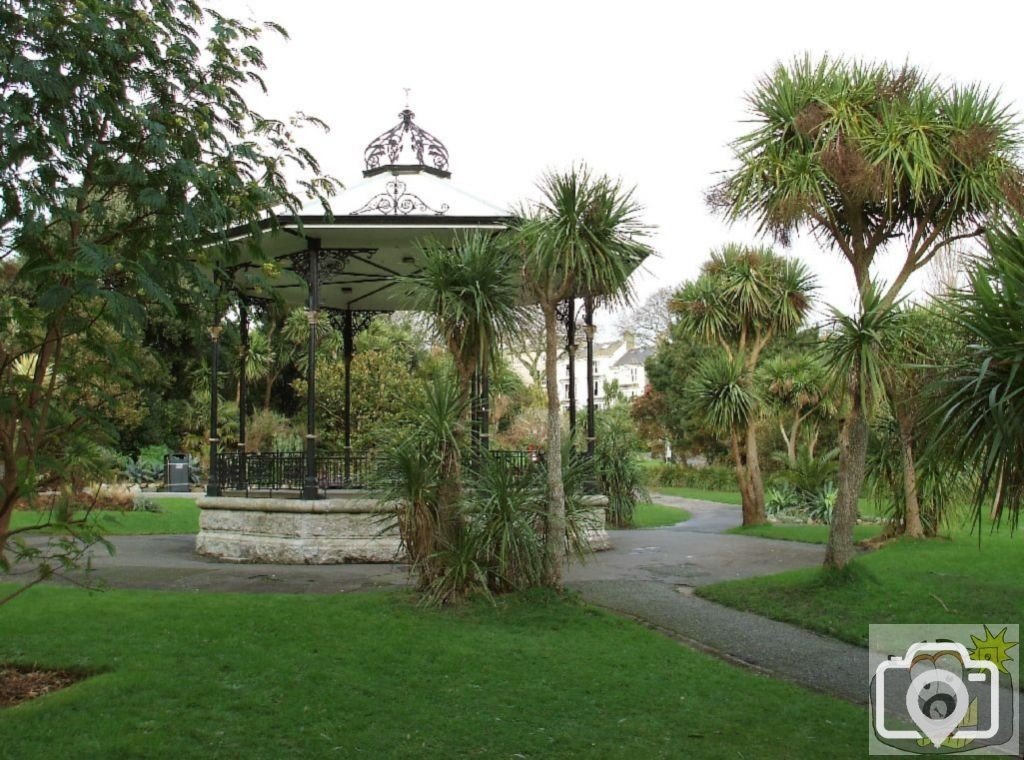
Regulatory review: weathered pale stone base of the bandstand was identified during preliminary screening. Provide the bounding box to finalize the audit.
[196,492,611,564]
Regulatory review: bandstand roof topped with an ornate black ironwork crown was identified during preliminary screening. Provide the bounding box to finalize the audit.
[222,109,510,311]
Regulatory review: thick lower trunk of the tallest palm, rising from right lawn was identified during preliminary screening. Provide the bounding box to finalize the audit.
[824,395,867,568]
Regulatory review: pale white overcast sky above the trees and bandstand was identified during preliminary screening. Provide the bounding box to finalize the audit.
[224,0,1024,331]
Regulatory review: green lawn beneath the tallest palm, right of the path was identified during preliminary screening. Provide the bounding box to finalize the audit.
[697,527,1024,644]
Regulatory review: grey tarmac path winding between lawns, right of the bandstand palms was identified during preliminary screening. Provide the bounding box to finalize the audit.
[568,494,868,704]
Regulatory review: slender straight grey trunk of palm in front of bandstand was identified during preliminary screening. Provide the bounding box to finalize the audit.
[544,303,565,589]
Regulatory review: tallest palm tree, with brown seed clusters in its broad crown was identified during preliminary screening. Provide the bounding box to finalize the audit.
[709,57,1024,567]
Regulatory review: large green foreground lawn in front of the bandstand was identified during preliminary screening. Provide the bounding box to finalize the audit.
[0,587,866,760]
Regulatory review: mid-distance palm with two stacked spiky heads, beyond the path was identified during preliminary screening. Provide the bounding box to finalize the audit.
[671,245,815,525]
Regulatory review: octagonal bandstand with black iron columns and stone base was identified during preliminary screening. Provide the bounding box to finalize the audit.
[196,108,607,563]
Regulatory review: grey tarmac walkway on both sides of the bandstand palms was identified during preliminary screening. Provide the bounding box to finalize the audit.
[61,495,867,703]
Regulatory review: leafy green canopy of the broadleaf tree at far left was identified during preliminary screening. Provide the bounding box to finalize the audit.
[0,0,337,549]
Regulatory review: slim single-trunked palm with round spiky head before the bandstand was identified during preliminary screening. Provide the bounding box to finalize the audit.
[515,165,651,588]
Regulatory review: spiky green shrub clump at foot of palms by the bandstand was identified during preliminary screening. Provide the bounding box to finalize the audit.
[379,372,589,604]
